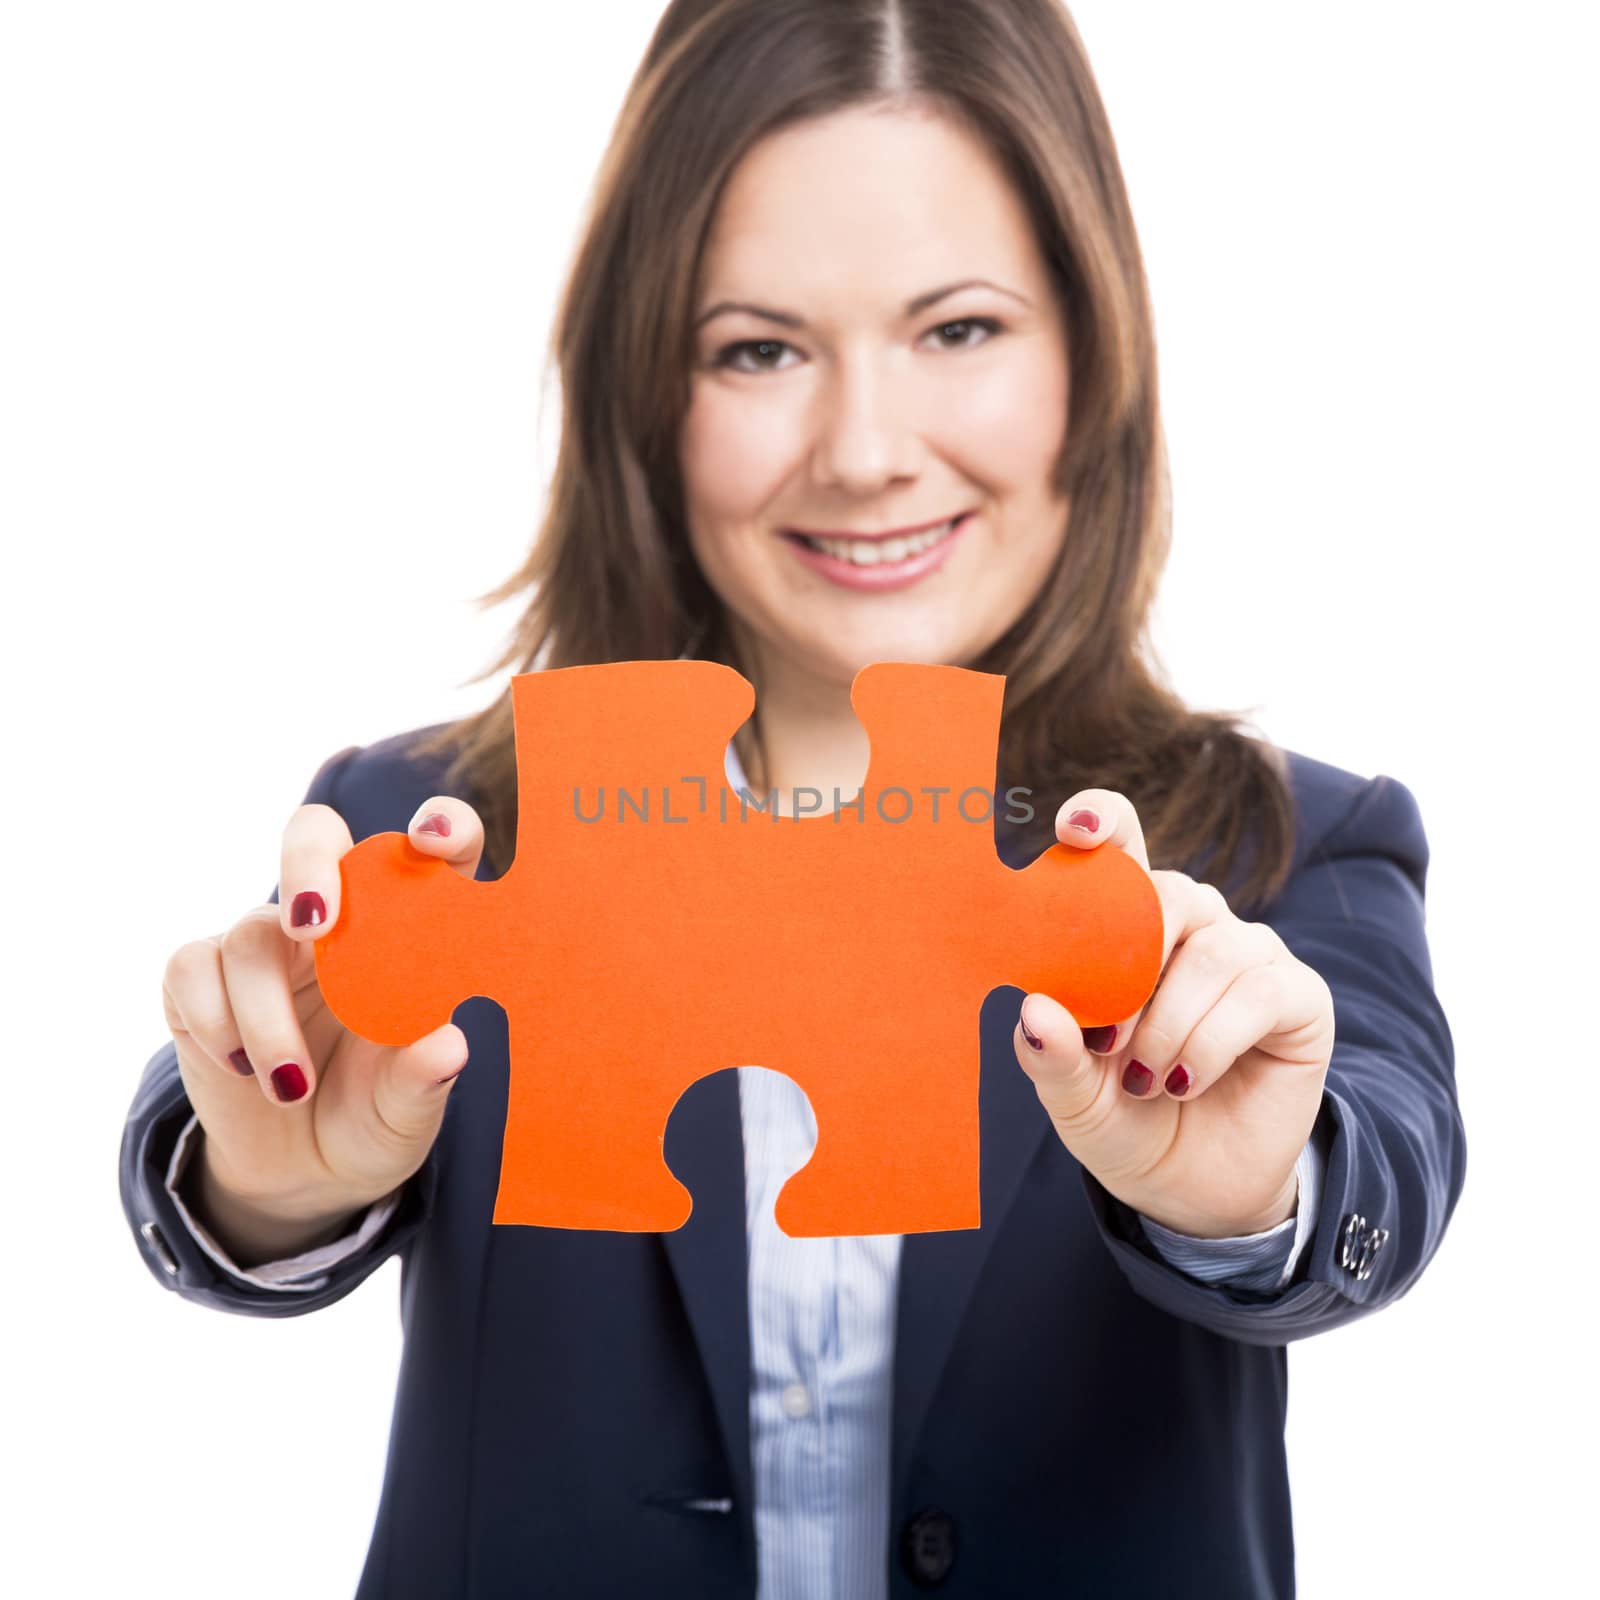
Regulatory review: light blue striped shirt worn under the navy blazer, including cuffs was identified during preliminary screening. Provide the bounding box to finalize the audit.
[166,742,1326,1600]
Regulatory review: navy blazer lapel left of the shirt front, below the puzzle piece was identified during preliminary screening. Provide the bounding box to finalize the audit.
[661,1067,755,1538]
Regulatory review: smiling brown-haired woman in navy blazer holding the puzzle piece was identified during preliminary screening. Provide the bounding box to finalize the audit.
[122,0,1466,1600]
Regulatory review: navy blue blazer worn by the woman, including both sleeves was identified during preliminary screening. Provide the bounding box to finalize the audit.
[120,734,1466,1600]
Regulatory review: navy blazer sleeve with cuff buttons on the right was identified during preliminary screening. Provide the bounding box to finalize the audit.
[1083,774,1467,1344]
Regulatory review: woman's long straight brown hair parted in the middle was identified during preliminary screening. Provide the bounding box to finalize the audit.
[418,0,1294,910]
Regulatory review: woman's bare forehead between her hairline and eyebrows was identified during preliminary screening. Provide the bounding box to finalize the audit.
[702,110,1043,306]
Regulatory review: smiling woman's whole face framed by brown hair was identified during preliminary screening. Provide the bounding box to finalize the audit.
[680,110,1067,685]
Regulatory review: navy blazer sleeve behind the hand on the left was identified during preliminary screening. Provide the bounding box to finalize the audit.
[118,746,438,1317]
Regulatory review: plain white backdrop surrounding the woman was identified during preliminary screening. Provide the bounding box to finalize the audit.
[0,0,1600,1600]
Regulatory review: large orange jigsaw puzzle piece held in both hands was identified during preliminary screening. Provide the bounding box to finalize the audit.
[315,661,1162,1238]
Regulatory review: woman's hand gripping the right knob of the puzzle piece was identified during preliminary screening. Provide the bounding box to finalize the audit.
[1014,789,1333,1238]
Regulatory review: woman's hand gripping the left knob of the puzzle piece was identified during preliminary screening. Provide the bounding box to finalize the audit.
[162,795,483,1259]
